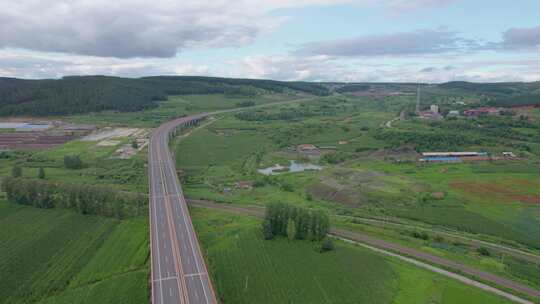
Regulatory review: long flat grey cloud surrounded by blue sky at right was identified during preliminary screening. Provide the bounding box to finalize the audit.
[296,28,475,56]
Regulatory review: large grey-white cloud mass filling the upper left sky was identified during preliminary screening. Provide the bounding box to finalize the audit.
[0,0,358,58]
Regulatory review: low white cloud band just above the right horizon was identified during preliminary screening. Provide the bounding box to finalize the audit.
[227,54,540,83]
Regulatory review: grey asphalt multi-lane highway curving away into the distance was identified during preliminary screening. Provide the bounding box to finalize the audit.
[148,115,217,304]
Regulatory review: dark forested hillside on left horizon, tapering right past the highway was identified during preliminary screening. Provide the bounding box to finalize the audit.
[0,76,328,116]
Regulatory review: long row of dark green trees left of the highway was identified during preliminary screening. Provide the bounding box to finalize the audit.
[2,177,148,219]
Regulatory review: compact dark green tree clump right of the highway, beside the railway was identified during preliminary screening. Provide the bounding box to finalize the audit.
[262,203,330,241]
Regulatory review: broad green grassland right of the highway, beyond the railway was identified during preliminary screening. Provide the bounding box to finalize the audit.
[175,97,540,247]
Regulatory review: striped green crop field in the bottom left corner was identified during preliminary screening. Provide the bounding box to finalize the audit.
[0,198,149,303]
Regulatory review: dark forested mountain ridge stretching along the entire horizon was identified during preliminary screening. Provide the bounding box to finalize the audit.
[0,76,540,116]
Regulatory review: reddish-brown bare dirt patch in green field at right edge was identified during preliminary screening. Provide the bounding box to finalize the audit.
[450,180,540,204]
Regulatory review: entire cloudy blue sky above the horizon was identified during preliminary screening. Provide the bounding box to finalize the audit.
[0,0,540,83]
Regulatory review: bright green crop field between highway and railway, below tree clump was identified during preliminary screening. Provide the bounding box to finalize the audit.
[191,208,506,303]
